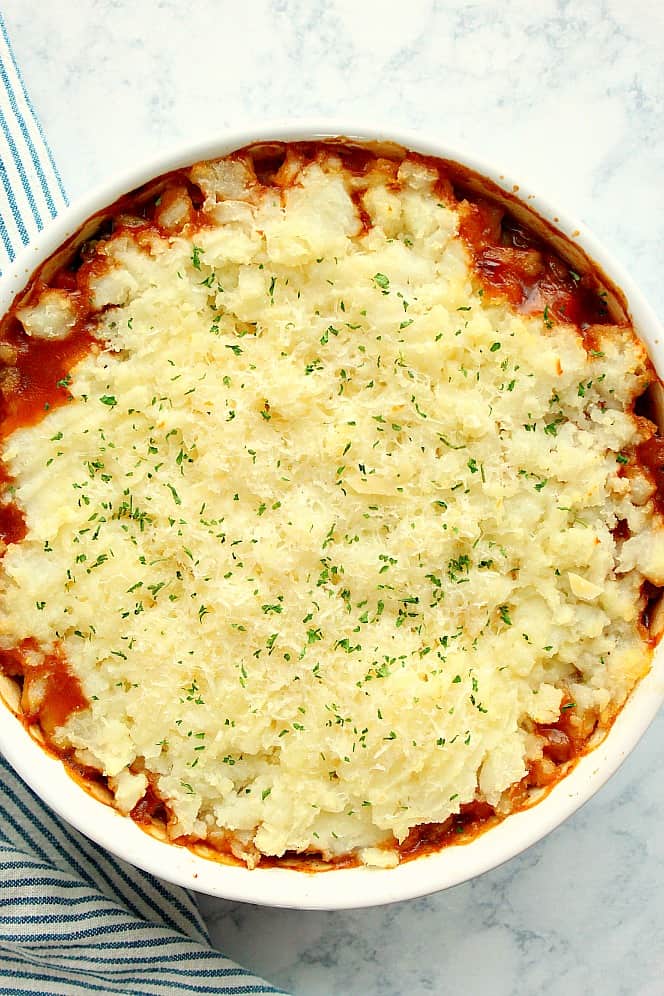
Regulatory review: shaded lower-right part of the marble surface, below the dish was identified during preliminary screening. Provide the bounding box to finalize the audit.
[202,715,664,996]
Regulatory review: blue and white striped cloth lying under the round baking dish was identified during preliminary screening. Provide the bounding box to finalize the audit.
[0,14,282,996]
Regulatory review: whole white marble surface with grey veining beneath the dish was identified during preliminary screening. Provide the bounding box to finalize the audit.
[2,0,664,996]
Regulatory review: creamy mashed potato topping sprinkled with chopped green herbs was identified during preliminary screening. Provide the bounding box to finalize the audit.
[0,149,664,864]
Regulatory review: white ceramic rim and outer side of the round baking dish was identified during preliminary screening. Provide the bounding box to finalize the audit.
[0,122,664,909]
